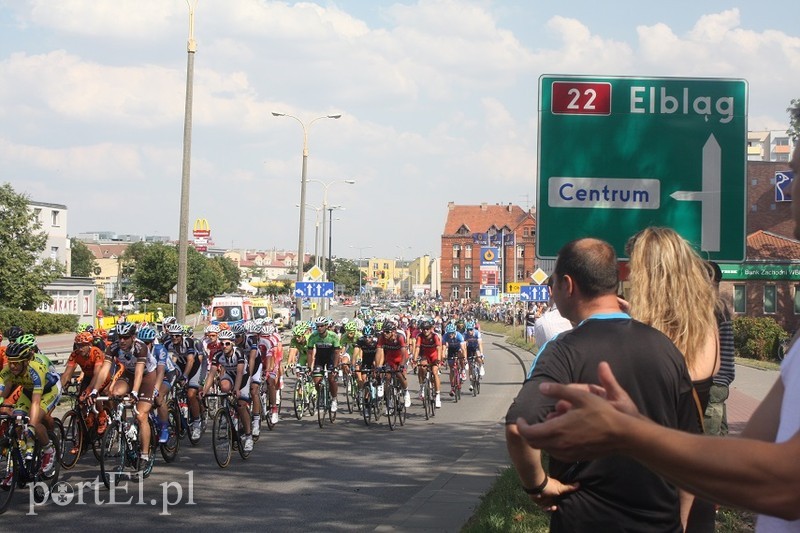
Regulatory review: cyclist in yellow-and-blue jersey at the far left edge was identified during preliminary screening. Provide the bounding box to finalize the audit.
[0,337,61,474]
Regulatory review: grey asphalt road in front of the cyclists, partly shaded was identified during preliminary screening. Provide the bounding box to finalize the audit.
[6,322,526,532]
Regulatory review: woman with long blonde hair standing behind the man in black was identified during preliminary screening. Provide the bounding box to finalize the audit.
[625,227,720,533]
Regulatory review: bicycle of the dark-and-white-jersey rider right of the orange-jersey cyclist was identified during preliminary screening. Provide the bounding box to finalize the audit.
[97,394,158,488]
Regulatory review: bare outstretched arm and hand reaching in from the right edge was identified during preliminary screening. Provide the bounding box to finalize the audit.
[517,364,800,520]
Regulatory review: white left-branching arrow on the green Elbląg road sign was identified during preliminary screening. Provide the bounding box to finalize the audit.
[670,133,722,252]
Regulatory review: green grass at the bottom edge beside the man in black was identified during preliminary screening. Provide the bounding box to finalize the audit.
[461,467,755,533]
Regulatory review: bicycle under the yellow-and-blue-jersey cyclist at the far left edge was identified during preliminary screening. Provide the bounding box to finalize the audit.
[0,414,61,514]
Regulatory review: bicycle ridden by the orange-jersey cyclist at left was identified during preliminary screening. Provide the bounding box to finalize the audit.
[59,392,103,470]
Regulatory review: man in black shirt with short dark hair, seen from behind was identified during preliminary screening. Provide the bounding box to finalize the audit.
[506,239,700,532]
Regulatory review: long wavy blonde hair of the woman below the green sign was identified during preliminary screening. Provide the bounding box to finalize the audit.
[626,227,717,369]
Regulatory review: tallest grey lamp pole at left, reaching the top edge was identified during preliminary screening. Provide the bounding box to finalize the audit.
[176,0,199,324]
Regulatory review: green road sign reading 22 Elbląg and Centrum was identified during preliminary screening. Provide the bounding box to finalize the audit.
[536,75,747,261]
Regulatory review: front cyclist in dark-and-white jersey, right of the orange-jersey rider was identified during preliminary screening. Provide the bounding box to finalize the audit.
[91,322,158,466]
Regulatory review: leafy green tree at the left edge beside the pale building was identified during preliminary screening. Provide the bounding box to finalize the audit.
[0,183,64,310]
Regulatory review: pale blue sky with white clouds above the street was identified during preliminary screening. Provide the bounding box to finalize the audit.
[0,0,800,258]
